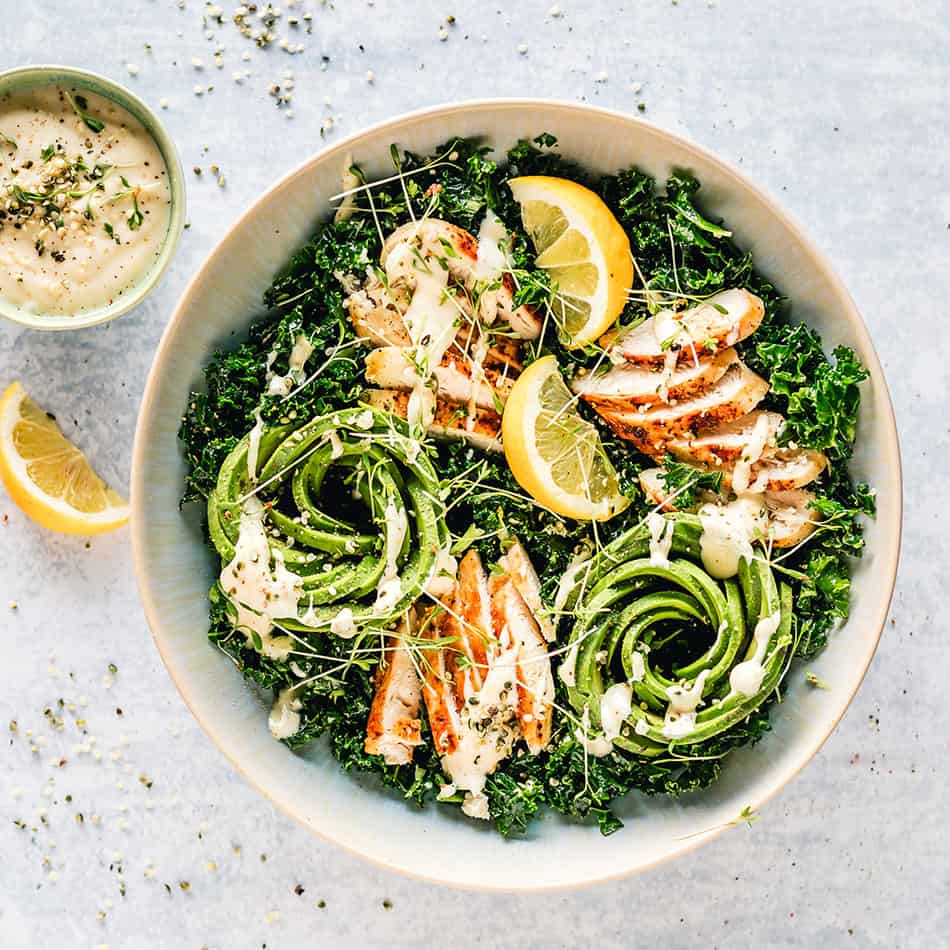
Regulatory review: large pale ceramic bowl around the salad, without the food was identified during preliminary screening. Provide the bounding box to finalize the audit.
[132,100,901,890]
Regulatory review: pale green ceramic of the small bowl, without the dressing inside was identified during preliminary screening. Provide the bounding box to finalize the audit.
[0,66,185,330]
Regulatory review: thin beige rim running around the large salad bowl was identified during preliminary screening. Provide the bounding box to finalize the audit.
[130,97,903,893]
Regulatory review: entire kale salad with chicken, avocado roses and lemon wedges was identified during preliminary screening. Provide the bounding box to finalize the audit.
[180,134,874,835]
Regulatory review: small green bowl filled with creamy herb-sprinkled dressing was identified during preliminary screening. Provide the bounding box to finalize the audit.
[0,66,185,330]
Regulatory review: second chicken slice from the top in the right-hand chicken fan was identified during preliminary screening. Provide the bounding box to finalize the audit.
[571,348,739,409]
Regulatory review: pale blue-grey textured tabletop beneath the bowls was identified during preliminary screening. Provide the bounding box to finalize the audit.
[0,0,950,950]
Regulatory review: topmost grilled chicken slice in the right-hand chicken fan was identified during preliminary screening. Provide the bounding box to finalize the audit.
[608,289,765,369]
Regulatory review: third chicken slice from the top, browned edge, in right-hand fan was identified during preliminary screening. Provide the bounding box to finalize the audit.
[596,360,769,455]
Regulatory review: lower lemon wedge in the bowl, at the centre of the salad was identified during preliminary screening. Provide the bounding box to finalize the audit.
[501,356,630,521]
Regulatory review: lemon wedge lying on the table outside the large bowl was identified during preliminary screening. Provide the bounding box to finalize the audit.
[0,383,129,534]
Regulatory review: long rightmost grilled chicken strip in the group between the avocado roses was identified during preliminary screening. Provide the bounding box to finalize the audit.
[491,574,554,755]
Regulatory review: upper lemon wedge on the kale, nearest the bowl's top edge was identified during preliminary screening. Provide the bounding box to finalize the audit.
[508,175,633,347]
